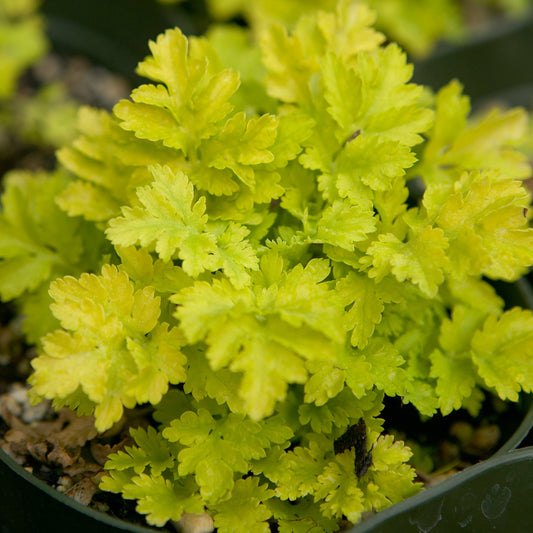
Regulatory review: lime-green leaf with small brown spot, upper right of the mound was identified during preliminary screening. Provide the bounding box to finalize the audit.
[324,46,432,197]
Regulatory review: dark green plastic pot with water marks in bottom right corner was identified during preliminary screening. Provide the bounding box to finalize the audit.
[351,447,533,533]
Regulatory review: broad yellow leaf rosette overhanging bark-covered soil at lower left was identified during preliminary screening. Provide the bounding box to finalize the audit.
[30,265,186,431]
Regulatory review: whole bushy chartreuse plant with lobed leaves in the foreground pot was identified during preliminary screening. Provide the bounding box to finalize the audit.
[0,1,533,533]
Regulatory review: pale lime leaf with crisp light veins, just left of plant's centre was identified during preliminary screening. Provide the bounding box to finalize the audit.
[106,166,257,286]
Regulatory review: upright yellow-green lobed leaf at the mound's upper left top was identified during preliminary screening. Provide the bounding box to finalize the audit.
[114,28,239,155]
